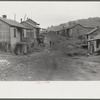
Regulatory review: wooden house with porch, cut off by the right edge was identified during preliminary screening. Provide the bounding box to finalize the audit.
[86,27,100,54]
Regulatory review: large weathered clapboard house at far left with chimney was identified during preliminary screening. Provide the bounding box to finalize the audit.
[0,15,30,53]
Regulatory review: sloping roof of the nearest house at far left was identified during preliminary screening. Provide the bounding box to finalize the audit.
[0,17,28,29]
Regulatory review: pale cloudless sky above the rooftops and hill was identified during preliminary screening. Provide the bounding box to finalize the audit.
[0,1,100,28]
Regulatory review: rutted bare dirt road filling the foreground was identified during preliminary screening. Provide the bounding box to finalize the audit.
[0,51,100,81]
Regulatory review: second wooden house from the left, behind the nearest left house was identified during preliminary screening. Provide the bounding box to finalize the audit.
[21,19,40,44]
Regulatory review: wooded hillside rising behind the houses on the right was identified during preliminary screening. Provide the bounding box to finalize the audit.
[47,17,100,31]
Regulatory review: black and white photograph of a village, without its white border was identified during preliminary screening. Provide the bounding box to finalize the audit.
[0,1,100,83]
